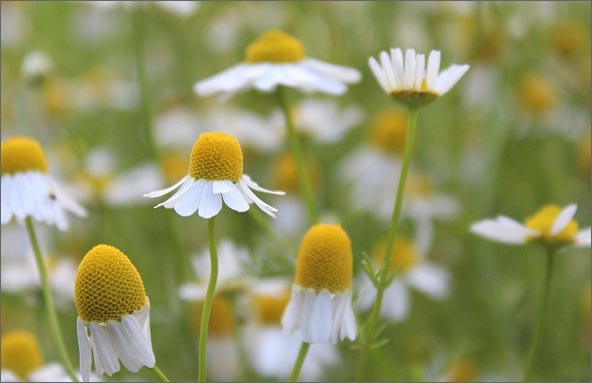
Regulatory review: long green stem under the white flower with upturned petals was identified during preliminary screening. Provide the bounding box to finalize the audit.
[358,108,419,378]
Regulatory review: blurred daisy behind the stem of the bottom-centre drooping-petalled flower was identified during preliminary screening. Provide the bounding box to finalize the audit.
[244,278,339,381]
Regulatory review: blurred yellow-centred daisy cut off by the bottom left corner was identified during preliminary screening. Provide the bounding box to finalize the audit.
[0,330,83,382]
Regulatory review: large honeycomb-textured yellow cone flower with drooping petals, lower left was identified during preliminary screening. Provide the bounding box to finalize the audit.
[74,245,155,382]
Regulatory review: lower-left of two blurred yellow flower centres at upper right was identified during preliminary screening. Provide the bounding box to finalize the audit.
[519,74,557,114]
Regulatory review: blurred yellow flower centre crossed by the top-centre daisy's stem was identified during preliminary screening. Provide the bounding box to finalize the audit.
[273,153,319,194]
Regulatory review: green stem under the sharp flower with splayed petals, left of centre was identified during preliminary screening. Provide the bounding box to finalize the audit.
[198,217,218,382]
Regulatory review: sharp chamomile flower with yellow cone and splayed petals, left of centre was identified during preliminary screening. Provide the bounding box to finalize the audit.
[144,132,284,219]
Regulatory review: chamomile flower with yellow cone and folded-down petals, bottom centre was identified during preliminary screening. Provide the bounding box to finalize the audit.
[282,225,357,343]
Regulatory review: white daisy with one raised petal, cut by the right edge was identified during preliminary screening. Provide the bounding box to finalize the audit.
[471,204,590,247]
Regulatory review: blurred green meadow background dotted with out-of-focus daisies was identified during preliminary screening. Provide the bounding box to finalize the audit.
[0,1,591,381]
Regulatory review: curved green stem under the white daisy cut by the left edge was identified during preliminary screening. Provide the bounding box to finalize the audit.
[25,217,79,382]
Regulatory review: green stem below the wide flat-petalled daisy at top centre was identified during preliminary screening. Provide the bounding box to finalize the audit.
[276,86,318,224]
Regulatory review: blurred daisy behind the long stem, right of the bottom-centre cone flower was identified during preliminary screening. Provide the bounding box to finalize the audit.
[358,237,450,322]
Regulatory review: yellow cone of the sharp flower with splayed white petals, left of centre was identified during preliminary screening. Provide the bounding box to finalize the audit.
[189,132,243,182]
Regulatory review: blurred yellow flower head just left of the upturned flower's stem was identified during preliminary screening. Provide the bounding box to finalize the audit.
[370,110,408,154]
